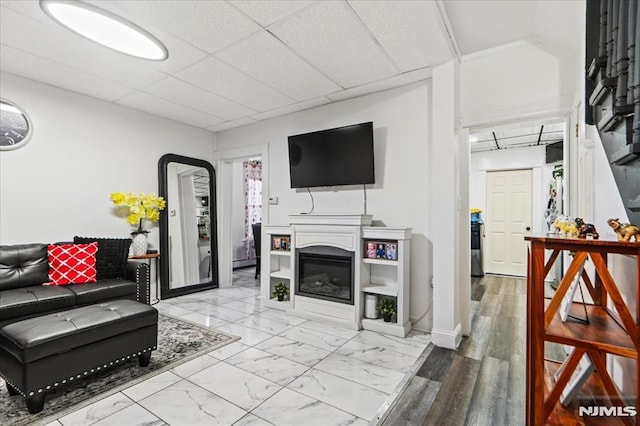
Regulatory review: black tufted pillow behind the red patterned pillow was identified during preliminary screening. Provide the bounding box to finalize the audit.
[73,236,131,280]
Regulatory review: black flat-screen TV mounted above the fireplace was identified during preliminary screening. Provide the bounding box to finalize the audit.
[289,122,375,188]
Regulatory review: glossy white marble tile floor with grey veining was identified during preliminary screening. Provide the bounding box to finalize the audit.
[41,268,433,426]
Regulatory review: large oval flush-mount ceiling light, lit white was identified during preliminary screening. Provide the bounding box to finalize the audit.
[40,0,169,61]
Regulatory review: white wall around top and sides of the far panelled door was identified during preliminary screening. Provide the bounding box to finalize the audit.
[469,146,553,235]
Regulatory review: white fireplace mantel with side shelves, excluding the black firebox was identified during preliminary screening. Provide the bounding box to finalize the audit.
[261,214,411,337]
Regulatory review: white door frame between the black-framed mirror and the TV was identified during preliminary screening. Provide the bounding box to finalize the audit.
[215,143,269,287]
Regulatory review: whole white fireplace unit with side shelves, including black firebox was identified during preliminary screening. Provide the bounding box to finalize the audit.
[261,214,411,337]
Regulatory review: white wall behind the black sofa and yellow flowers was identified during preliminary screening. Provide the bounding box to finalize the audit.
[0,73,214,248]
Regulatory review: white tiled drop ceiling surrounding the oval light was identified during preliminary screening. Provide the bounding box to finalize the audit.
[0,0,582,131]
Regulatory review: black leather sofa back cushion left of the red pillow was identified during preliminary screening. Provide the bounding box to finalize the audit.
[0,244,49,290]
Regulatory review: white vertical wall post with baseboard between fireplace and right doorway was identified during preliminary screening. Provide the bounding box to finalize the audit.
[429,61,464,349]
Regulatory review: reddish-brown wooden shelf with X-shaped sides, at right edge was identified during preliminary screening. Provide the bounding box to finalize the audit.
[525,237,640,426]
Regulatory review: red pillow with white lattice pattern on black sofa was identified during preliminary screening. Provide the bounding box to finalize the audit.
[45,242,98,285]
